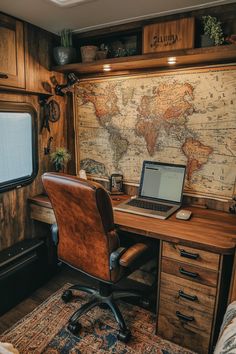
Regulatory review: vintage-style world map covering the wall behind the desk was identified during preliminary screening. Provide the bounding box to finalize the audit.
[76,66,236,199]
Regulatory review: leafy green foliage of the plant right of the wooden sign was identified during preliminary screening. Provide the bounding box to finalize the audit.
[202,15,224,45]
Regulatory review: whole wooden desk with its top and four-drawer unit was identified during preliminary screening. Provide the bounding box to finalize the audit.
[30,195,236,353]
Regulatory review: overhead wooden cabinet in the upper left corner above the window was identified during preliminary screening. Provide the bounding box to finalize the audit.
[0,14,65,95]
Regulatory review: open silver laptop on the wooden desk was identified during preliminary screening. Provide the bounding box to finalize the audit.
[113,161,186,219]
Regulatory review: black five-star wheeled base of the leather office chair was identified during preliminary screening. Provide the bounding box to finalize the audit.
[62,283,142,343]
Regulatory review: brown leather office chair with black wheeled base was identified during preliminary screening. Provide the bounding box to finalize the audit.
[42,173,148,342]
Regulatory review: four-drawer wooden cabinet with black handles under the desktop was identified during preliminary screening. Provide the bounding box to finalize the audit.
[157,242,227,354]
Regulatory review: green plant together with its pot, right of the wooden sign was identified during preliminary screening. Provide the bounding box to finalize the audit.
[201,15,224,47]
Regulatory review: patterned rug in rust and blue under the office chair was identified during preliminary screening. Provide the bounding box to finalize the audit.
[0,284,193,354]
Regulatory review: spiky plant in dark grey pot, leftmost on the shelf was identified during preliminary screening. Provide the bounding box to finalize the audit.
[53,29,76,65]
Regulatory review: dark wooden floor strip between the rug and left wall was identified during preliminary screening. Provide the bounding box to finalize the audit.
[0,266,94,334]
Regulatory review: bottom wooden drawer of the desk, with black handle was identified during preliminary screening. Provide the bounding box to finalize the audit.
[157,300,212,354]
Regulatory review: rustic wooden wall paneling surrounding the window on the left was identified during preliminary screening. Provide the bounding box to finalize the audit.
[0,92,67,250]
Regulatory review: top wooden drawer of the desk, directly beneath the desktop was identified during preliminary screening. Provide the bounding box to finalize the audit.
[162,242,220,271]
